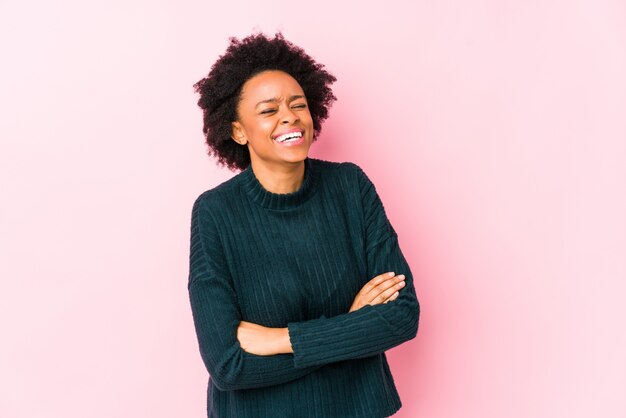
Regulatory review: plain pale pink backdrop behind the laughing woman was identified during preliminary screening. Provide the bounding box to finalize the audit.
[0,0,626,418]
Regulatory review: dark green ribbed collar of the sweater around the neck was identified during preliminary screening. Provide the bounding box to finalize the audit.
[242,157,319,210]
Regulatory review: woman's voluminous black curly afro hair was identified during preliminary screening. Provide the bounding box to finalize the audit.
[194,32,337,171]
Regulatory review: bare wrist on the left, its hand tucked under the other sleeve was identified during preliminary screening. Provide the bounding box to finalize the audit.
[237,321,293,356]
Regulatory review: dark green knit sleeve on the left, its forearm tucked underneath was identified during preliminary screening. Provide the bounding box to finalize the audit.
[188,199,319,390]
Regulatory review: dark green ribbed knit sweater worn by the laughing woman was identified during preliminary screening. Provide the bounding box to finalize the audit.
[188,158,420,418]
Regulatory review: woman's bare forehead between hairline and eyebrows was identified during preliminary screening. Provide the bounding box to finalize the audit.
[241,70,304,101]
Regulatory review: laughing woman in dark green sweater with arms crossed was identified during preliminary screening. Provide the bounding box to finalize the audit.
[188,34,419,418]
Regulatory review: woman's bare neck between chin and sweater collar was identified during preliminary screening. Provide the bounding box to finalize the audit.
[250,160,304,194]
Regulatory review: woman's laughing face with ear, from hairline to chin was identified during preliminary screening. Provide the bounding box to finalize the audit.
[232,71,313,168]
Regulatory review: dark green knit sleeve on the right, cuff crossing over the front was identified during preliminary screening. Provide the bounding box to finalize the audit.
[288,166,420,368]
